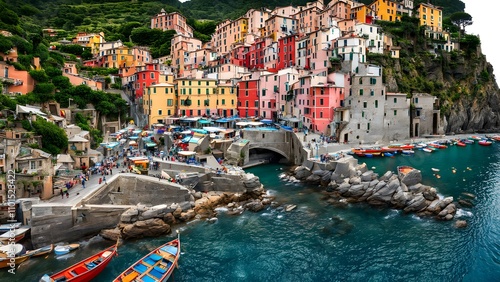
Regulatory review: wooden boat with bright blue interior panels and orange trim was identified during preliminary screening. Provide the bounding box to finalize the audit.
[113,238,181,282]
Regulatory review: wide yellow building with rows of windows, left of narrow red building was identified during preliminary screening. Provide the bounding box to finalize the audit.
[176,78,217,117]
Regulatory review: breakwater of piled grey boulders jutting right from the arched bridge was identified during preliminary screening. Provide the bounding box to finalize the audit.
[282,156,457,220]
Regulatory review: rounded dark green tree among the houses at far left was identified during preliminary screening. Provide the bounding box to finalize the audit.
[32,118,68,155]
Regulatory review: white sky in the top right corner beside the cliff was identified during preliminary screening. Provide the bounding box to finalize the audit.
[462,0,500,83]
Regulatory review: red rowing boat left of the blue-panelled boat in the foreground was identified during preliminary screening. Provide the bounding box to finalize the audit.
[42,245,118,282]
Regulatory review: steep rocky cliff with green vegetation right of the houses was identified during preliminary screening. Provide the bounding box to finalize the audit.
[368,23,500,133]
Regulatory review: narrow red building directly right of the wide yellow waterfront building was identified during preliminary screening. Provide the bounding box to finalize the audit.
[238,79,260,117]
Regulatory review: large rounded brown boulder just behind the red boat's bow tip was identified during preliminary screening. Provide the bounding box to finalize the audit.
[122,218,171,239]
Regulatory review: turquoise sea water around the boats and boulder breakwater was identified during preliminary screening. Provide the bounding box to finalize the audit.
[4,143,500,281]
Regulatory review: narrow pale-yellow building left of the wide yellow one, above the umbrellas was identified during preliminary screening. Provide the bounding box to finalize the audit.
[143,75,177,125]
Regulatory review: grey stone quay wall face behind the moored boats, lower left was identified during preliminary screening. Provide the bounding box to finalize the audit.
[31,205,130,248]
